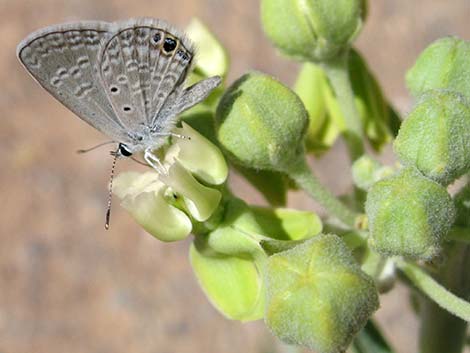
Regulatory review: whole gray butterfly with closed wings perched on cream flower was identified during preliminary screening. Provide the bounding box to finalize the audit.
[17,18,221,225]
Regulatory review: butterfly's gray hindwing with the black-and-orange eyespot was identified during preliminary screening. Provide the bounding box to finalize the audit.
[98,18,194,131]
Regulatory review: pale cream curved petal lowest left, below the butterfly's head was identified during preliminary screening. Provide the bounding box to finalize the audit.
[113,172,192,241]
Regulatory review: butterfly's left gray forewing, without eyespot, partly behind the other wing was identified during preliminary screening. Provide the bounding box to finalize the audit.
[17,21,130,142]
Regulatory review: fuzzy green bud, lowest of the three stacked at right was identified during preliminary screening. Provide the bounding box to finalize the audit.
[366,168,455,260]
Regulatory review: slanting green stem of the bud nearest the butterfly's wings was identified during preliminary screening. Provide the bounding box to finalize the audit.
[285,156,361,228]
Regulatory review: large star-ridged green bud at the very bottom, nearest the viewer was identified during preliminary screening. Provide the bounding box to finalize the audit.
[265,234,379,353]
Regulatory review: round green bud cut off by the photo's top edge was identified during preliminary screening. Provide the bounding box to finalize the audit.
[261,0,366,61]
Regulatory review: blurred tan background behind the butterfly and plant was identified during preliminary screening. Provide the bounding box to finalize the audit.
[0,0,470,353]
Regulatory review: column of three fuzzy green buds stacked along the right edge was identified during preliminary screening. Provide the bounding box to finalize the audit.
[366,38,470,260]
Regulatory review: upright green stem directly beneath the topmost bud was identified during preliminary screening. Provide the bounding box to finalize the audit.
[323,51,364,161]
